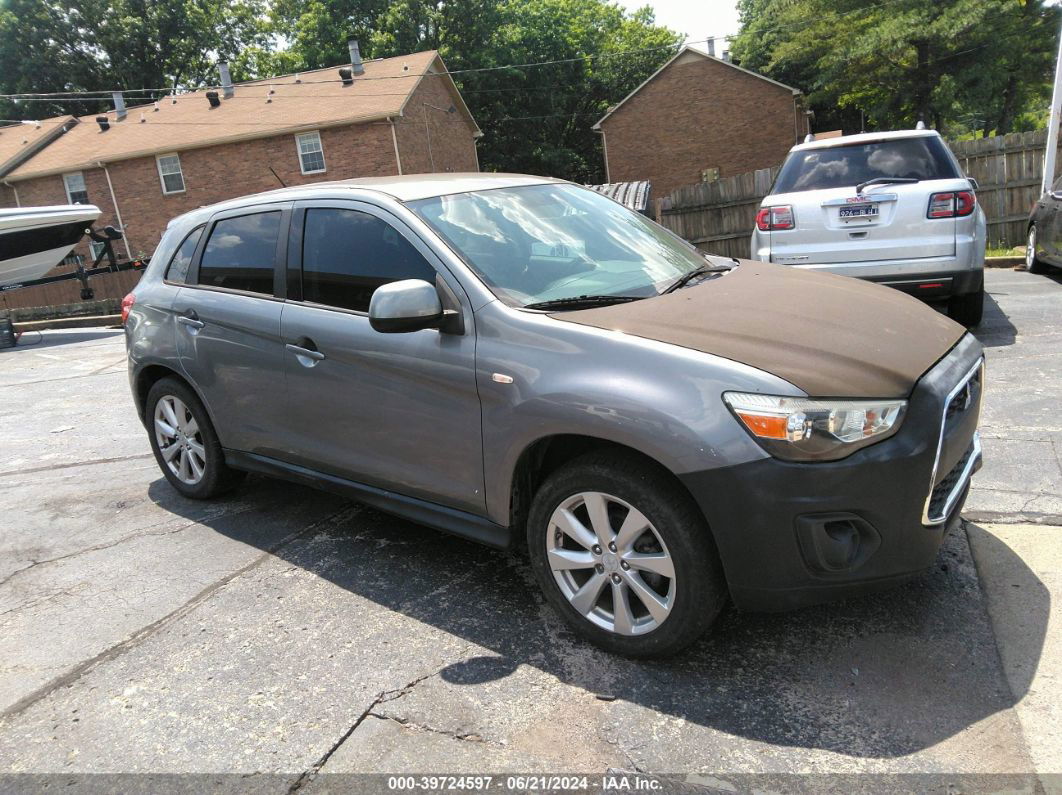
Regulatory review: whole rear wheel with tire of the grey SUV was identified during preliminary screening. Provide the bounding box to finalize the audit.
[144,378,246,500]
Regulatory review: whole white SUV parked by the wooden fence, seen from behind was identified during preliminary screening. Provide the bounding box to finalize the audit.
[752,129,986,326]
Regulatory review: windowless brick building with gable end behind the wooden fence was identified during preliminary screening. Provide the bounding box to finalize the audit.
[594,47,808,198]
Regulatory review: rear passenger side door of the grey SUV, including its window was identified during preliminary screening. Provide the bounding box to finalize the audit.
[173,203,291,454]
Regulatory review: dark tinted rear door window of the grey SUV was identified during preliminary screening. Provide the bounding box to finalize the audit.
[199,212,280,295]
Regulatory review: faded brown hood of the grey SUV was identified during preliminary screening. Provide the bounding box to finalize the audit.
[550,260,965,398]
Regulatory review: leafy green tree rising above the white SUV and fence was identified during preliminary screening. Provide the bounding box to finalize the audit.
[733,0,1059,135]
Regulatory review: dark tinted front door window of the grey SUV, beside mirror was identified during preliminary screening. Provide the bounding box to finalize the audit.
[303,208,435,312]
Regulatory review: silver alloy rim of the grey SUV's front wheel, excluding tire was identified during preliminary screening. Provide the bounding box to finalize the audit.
[546,491,675,635]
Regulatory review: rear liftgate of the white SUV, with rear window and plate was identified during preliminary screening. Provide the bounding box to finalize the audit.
[764,136,970,265]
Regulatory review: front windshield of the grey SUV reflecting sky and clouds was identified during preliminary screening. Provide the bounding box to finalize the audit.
[410,185,708,307]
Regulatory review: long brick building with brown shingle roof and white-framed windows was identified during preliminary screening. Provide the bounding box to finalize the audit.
[0,51,482,266]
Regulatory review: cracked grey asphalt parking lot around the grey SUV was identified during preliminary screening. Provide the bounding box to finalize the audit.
[0,270,1062,789]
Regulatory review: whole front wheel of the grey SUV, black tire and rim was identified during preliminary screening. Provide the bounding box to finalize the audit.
[527,453,726,657]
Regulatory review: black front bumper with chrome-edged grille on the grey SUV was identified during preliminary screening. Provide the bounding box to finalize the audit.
[683,334,982,610]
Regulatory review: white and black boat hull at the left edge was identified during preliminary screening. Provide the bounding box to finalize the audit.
[0,204,100,288]
